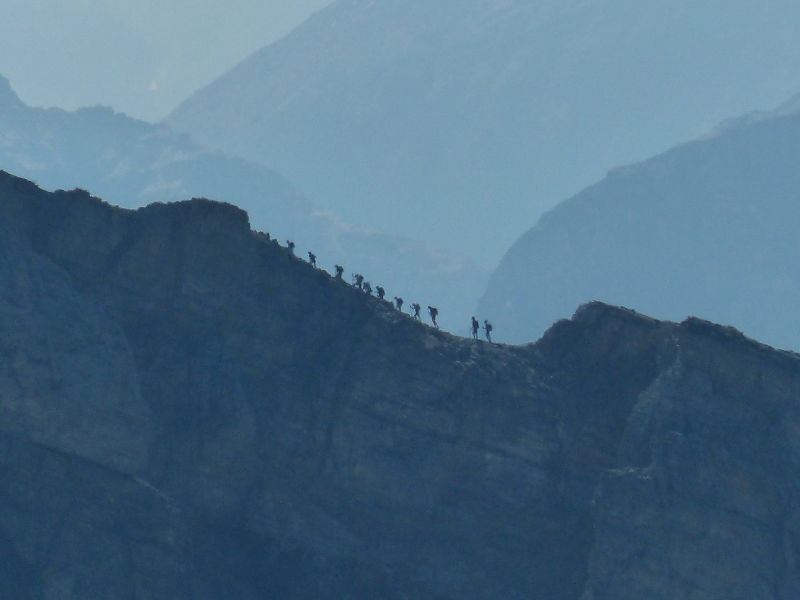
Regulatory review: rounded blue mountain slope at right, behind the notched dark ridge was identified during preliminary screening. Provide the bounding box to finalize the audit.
[480,98,800,349]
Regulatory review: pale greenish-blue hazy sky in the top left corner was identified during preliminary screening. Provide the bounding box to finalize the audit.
[0,0,331,121]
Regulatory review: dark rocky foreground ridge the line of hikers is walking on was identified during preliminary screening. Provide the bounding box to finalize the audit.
[0,175,800,600]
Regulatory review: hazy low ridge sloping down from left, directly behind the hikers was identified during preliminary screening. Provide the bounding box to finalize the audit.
[0,78,486,330]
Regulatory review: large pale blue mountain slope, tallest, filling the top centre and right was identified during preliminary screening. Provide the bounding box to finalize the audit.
[167,0,800,264]
